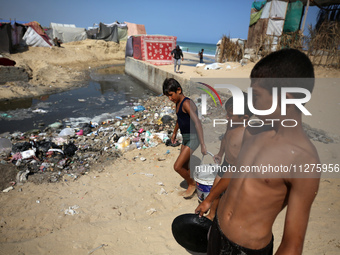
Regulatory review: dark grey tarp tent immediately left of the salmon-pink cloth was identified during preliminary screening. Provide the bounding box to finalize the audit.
[97,22,128,43]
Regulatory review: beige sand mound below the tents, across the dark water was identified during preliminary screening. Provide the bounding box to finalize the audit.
[0,39,126,100]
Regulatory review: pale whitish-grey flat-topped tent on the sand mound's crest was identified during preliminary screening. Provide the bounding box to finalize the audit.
[49,23,87,43]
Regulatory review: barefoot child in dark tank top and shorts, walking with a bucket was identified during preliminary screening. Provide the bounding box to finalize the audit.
[163,78,207,198]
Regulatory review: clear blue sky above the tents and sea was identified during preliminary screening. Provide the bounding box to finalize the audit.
[0,0,318,44]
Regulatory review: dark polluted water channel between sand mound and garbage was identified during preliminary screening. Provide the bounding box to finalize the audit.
[0,65,156,134]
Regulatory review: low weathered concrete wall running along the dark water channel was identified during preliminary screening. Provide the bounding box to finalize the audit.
[125,57,190,94]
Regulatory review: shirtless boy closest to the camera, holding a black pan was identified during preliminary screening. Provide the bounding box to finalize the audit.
[196,49,320,255]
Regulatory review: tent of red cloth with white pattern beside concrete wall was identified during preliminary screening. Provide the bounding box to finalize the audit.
[133,35,177,65]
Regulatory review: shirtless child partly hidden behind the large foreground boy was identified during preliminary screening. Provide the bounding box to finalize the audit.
[202,93,252,220]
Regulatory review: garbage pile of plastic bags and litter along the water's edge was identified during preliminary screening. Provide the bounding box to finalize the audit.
[0,97,180,189]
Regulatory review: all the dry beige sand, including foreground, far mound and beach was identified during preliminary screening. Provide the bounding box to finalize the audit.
[0,40,340,255]
